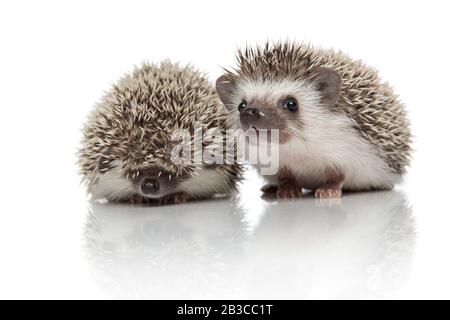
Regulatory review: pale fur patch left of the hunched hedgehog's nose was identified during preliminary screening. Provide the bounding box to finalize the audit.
[91,163,134,201]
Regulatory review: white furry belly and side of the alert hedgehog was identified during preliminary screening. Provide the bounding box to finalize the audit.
[268,132,401,190]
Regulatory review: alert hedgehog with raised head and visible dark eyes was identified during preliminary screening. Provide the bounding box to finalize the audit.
[216,41,411,199]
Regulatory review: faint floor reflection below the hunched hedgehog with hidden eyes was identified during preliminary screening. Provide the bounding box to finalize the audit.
[85,200,245,298]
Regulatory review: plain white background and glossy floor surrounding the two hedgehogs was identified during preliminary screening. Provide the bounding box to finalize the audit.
[0,0,450,298]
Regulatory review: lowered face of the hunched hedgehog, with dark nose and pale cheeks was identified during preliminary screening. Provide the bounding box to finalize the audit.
[85,124,236,200]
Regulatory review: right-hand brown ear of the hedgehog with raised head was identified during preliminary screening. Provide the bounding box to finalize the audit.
[313,67,341,106]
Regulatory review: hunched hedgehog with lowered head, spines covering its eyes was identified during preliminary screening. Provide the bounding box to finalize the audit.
[78,60,242,204]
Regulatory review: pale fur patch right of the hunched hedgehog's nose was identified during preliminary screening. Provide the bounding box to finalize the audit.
[177,168,230,198]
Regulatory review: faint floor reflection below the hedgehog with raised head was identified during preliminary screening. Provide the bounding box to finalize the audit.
[240,191,415,299]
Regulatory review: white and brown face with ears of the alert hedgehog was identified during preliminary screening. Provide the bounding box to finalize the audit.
[216,68,340,144]
